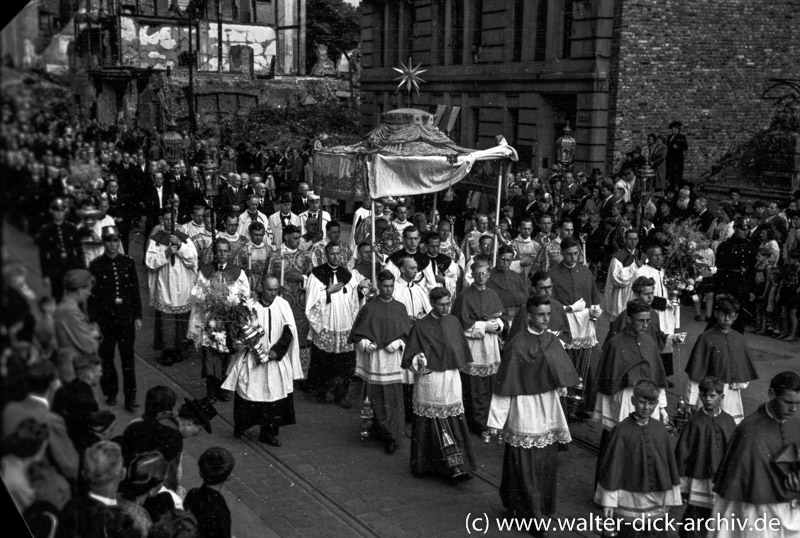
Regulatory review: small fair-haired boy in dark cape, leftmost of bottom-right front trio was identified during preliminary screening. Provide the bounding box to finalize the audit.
[594,379,681,536]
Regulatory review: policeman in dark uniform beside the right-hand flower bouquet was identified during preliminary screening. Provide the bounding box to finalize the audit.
[714,217,757,333]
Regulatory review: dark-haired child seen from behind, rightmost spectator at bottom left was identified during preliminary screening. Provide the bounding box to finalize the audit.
[183,446,235,538]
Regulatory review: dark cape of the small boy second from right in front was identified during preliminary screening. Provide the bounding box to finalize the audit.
[675,409,736,480]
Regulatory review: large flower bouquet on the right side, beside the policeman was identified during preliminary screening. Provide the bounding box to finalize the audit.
[663,222,708,303]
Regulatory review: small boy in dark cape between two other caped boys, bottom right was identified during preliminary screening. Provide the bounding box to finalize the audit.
[675,376,736,538]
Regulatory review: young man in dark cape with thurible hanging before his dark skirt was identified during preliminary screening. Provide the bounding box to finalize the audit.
[401,288,475,479]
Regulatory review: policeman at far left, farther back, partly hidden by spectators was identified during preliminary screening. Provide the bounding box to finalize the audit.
[36,198,85,301]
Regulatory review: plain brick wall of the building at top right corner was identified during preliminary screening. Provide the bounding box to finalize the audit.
[607,0,800,179]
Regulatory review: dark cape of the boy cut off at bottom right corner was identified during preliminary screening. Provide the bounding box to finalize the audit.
[714,404,800,504]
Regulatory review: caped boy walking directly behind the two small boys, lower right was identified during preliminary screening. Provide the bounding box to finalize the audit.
[686,295,758,424]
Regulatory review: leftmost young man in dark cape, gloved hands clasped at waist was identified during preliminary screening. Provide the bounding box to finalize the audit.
[349,270,411,454]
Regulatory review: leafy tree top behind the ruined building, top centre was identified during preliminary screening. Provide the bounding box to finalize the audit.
[306,0,361,72]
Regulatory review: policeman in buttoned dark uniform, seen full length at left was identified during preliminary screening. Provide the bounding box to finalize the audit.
[88,226,142,411]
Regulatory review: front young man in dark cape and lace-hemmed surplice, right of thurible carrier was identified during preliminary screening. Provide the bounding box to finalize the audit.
[489,295,580,517]
